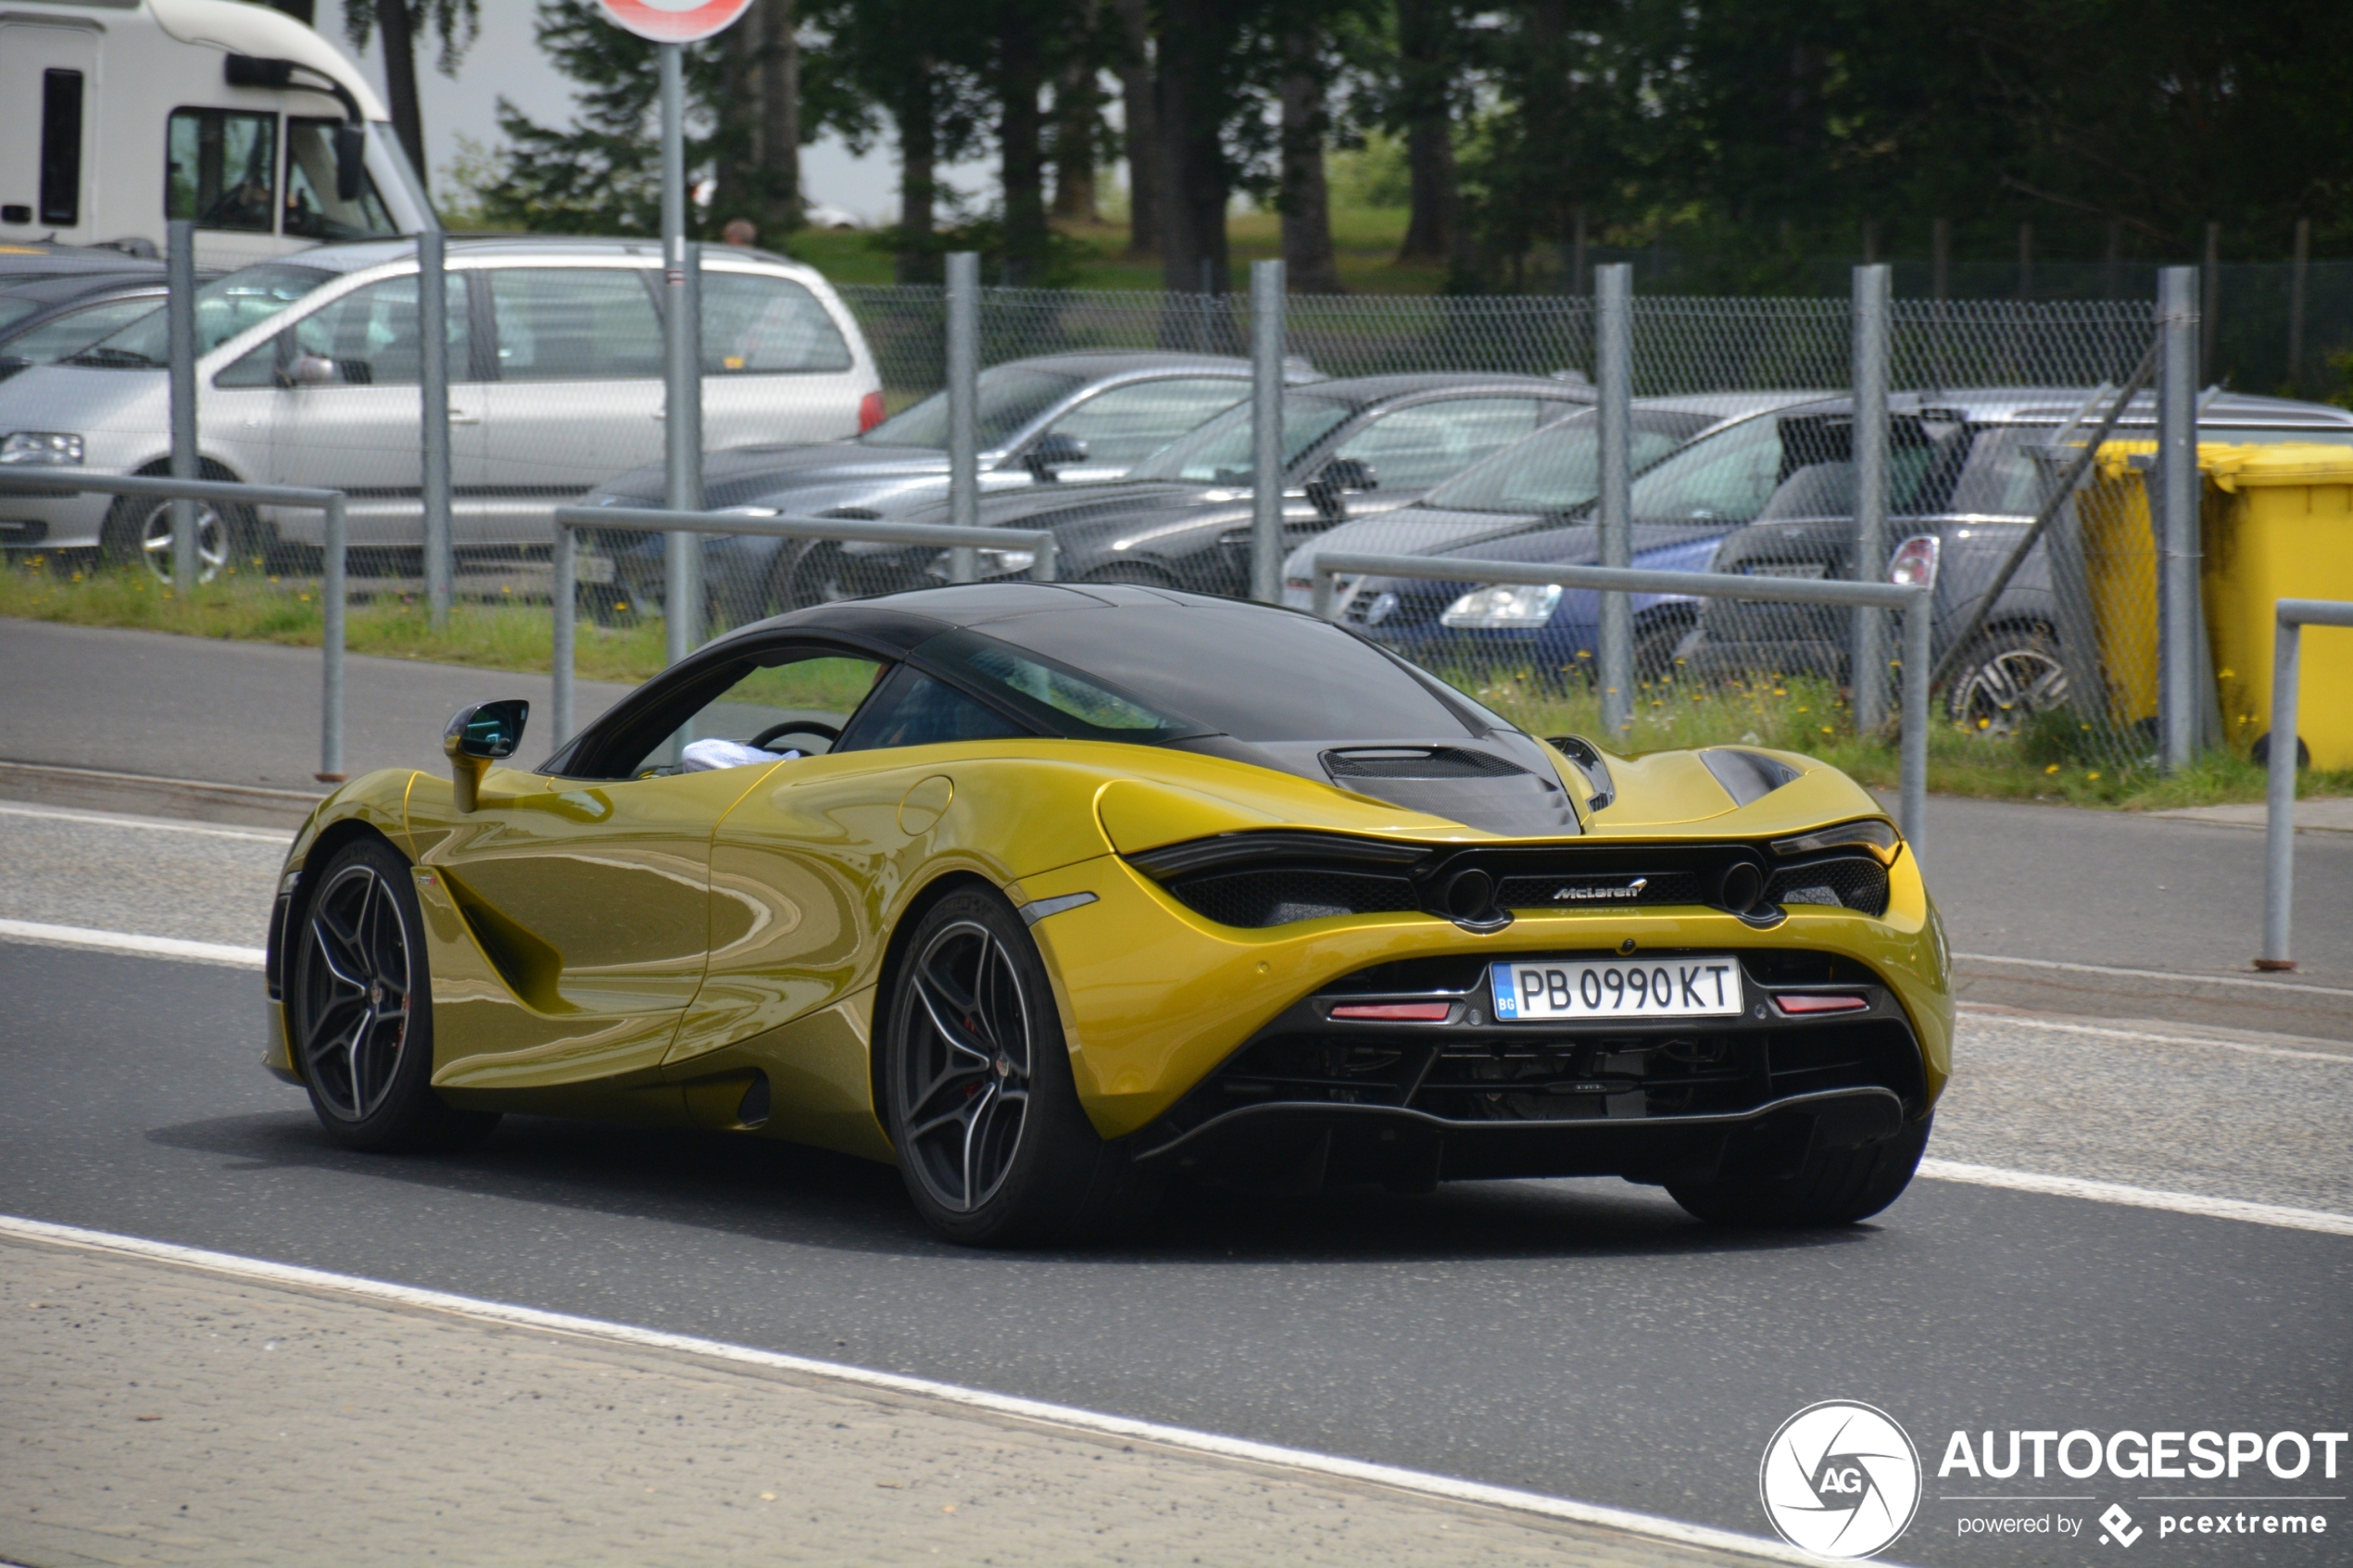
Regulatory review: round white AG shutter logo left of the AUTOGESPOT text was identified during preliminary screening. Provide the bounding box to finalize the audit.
[1757,1399,1920,1556]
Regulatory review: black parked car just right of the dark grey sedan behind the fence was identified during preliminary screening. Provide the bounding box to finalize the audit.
[842,371,1593,595]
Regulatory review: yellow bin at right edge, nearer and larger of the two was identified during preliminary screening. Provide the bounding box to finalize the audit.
[2197,442,2353,769]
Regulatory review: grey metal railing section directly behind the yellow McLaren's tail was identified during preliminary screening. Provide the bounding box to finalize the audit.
[1315,550,1934,853]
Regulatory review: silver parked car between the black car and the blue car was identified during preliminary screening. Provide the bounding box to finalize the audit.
[1282,393,1821,611]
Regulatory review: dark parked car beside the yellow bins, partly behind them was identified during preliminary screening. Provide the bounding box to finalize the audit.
[1680,388,2353,731]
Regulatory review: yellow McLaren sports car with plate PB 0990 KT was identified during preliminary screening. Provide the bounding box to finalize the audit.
[266,583,1953,1246]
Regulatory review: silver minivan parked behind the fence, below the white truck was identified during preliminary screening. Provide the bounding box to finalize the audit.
[0,240,883,576]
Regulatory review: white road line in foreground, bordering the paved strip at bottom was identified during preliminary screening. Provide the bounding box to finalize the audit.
[0,1215,1821,1568]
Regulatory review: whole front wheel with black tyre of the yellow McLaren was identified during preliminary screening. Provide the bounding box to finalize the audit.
[287,839,498,1149]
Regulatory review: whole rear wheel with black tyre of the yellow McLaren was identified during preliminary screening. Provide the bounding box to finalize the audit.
[880,888,1160,1246]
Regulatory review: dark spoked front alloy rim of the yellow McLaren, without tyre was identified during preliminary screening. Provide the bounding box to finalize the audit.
[299,865,412,1122]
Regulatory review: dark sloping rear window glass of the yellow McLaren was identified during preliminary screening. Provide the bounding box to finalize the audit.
[955,604,1471,743]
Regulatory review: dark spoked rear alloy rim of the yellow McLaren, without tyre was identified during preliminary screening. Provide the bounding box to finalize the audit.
[897,919,1031,1213]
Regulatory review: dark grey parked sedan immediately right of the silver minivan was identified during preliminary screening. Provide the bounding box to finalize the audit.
[581,350,1320,621]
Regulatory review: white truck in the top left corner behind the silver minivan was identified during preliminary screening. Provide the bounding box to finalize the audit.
[0,0,428,270]
